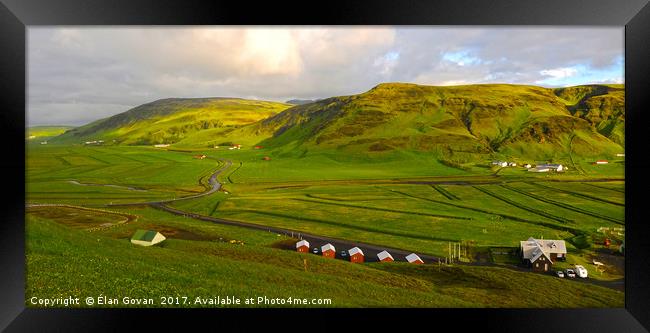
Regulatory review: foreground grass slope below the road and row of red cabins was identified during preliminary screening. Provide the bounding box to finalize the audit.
[26,209,623,307]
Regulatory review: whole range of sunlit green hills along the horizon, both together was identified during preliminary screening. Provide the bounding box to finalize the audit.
[52,83,625,164]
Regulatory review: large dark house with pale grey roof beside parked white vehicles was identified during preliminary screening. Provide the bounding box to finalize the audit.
[519,237,566,272]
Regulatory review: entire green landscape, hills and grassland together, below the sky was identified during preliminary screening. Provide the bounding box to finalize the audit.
[26,84,625,307]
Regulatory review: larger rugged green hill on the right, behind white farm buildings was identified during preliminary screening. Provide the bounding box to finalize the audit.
[247,83,625,161]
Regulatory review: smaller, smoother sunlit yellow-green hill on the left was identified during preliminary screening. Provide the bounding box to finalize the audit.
[53,98,291,145]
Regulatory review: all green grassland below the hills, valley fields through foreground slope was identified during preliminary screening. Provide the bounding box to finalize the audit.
[26,146,625,307]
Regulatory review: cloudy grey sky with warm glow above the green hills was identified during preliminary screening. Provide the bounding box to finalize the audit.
[27,26,624,126]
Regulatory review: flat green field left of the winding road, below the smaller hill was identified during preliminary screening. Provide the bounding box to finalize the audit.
[26,145,222,205]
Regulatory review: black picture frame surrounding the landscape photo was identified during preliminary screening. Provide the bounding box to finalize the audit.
[0,0,650,332]
